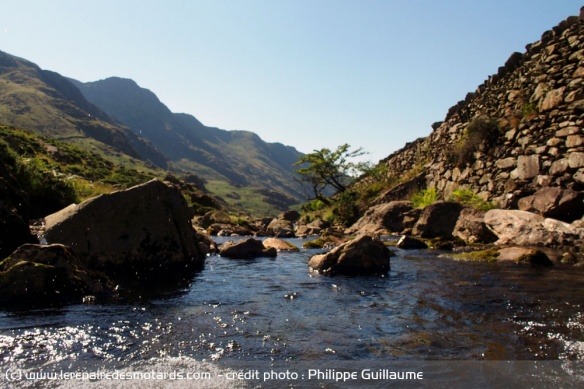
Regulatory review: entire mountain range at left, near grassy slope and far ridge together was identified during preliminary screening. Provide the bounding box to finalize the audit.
[0,51,304,214]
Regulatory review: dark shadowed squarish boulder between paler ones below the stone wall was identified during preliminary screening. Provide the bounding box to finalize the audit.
[412,201,464,238]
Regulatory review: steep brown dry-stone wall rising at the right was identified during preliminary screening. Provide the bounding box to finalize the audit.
[376,9,584,222]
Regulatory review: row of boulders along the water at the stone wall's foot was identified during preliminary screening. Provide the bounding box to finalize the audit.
[345,197,584,246]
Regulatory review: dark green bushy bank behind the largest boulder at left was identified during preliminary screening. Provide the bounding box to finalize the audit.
[0,126,160,218]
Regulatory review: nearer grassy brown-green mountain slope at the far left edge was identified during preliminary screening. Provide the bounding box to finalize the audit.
[0,51,167,168]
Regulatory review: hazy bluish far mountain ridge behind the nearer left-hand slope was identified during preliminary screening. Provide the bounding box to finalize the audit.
[71,77,303,200]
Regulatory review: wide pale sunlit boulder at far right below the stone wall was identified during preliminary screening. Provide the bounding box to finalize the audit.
[485,209,584,246]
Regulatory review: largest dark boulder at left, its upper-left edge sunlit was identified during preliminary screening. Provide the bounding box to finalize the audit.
[45,180,205,275]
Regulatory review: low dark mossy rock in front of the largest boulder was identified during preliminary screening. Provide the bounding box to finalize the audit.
[0,244,115,304]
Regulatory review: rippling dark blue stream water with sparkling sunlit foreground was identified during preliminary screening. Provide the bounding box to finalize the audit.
[0,235,584,387]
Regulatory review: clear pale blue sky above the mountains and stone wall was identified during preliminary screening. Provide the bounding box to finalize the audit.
[0,0,584,162]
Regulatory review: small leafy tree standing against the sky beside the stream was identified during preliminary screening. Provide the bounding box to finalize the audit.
[292,143,368,204]
